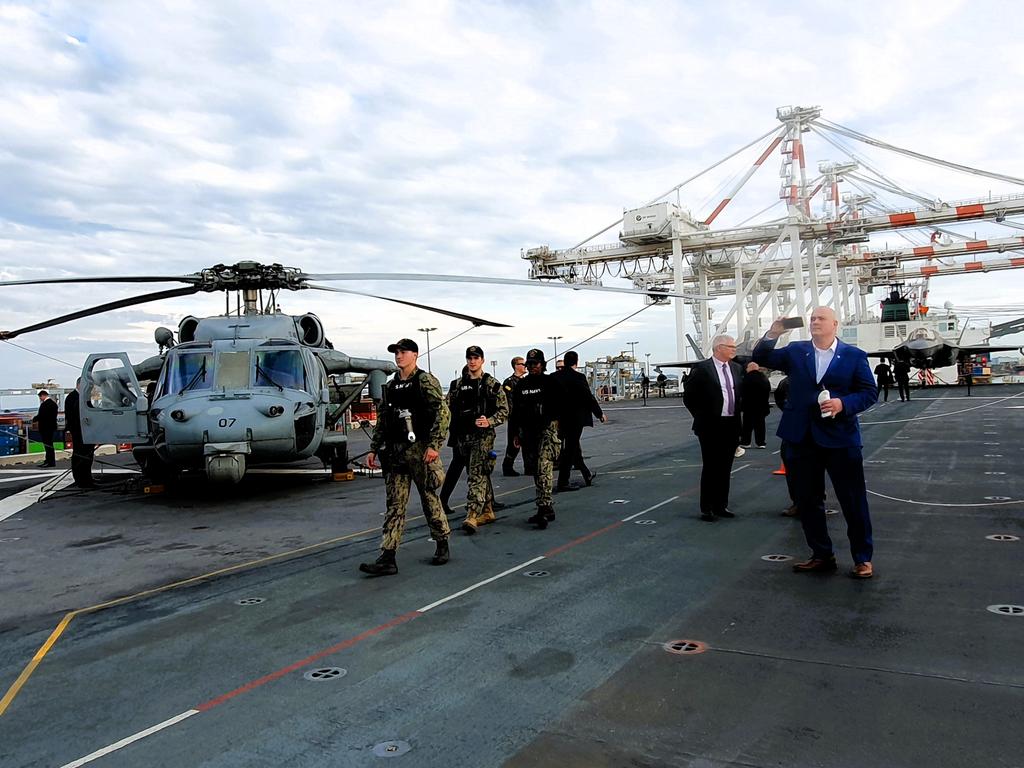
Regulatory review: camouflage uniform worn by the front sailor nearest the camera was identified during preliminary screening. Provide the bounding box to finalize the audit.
[370,369,451,551]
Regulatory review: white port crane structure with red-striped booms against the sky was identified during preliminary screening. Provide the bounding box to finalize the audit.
[521,106,1024,359]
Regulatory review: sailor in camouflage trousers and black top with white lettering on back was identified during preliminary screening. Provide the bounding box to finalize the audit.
[509,349,562,528]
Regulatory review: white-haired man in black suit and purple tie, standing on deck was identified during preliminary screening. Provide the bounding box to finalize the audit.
[683,334,743,522]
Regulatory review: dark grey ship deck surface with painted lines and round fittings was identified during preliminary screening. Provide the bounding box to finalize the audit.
[0,386,1024,768]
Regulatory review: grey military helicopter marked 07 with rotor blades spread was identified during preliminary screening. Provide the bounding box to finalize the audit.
[0,261,704,483]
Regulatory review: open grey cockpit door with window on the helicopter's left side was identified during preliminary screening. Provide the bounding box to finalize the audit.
[78,352,148,445]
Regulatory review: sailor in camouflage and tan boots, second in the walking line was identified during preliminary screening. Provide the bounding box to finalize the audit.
[447,346,509,534]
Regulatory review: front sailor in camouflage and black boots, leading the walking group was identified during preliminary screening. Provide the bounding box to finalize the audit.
[359,339,450,575]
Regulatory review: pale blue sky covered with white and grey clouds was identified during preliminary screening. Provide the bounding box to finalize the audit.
[0,0,1024,403]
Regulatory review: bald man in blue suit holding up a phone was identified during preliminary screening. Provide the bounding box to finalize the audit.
[754,307,879,579]
